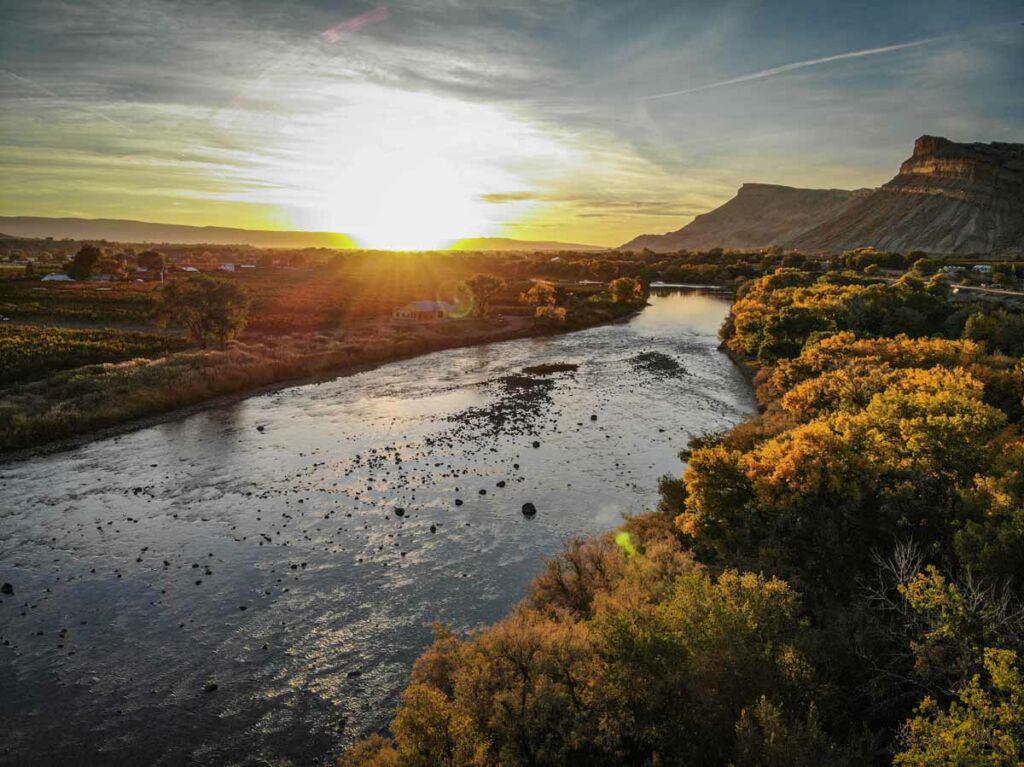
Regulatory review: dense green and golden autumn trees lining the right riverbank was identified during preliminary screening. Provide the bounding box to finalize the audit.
[341,269,1024,767]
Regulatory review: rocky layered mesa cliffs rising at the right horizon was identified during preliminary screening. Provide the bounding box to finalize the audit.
[622,135,1024,255]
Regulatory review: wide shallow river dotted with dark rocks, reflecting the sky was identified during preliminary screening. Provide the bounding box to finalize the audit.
[0,291,755,765]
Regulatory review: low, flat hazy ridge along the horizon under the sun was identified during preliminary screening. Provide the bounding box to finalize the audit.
[0,216,607,251]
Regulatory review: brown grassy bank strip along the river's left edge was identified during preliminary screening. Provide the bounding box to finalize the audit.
[0,302,642,463]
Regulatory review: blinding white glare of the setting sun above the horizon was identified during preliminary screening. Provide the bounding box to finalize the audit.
[239,84,569,250]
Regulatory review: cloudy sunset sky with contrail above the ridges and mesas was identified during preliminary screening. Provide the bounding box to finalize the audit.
[0,0,1024,249]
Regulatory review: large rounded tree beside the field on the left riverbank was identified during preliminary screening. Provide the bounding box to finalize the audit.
[157,274,250,349]
